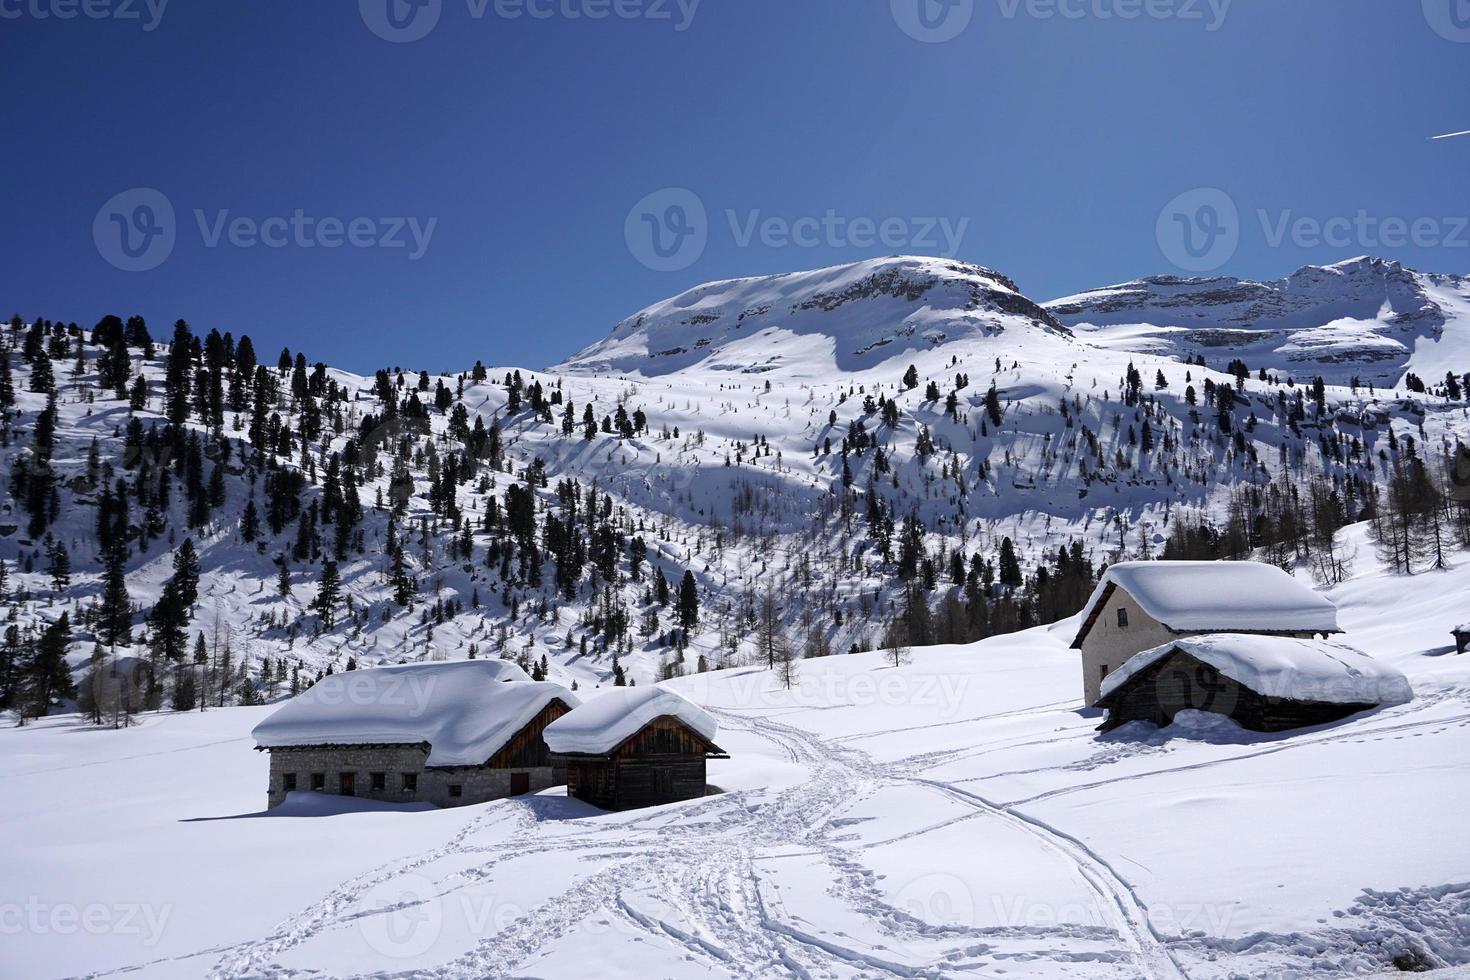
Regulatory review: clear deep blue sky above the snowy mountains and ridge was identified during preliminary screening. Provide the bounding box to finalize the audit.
[0,0,1470,370]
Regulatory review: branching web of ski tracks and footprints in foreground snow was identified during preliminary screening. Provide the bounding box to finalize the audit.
[198,708,1185,980]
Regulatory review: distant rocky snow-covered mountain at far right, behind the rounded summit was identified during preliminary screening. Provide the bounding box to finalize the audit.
[1044,257,1470,385]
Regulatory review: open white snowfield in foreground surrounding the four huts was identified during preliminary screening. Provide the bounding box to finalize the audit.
[0,527,1470,980]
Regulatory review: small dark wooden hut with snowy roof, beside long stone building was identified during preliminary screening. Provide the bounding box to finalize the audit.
[545,688,728,810]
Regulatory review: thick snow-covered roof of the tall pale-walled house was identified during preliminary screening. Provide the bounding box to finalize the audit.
[1072,561,1341,646]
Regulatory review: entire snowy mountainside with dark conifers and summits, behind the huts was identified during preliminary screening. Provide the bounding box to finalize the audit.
[0,257,1470,714]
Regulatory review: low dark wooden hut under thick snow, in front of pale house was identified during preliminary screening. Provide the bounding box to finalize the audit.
[1098,633,1414,732]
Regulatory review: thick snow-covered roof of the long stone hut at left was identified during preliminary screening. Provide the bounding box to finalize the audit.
[251,660,581,765]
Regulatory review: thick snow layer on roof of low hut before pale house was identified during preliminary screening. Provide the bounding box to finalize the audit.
[1103,633,1414,704]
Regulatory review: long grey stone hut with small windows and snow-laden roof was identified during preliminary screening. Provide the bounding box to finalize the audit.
[251,660,581,807]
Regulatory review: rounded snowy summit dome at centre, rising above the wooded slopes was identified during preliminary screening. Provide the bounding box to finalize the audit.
[553,256,1069,381]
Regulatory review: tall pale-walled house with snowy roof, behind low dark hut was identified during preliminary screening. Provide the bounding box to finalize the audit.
[1072,561,1342,707]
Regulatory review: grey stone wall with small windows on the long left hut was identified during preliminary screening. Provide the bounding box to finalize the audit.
[266,745,566,807]
